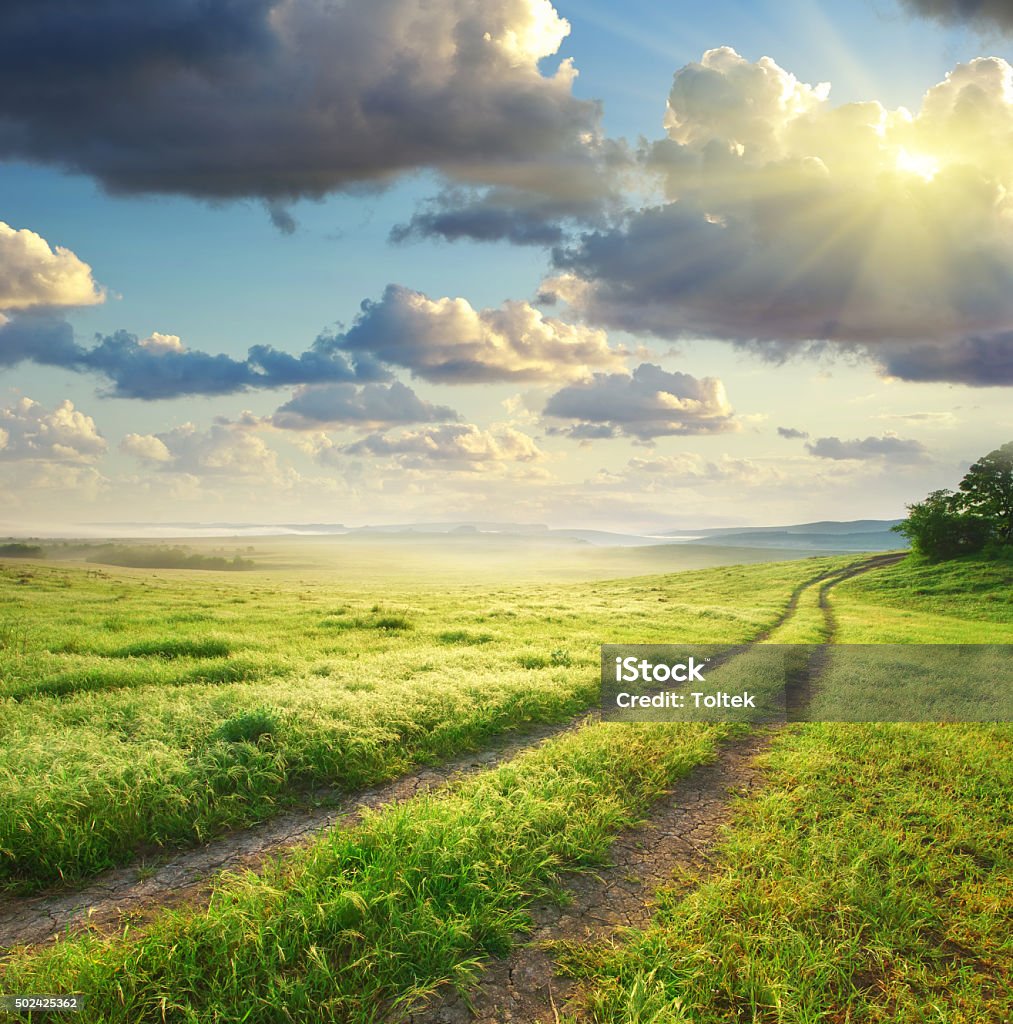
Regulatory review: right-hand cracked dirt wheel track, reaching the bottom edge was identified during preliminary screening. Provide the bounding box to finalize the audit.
[403,555,904,1024]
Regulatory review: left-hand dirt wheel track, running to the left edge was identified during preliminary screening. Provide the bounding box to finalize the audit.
[0,556,902,958]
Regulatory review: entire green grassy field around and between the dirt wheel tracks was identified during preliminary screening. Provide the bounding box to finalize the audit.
[0,549,1013,1024]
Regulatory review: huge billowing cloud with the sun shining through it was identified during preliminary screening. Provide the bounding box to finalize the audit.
[545,47,1013,383]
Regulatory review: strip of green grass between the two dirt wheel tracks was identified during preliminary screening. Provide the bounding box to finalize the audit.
[3,724,732,1024]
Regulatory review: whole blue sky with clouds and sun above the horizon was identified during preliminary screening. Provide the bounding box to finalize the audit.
[0,0,1013,535]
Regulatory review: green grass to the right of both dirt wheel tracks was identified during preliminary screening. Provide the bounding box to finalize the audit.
[557,559,1013,1024]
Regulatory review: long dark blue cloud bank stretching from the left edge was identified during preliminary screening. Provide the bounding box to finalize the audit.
[0,314,390,400]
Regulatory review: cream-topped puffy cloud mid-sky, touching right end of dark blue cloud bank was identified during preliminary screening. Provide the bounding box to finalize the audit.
[338,285,626,384]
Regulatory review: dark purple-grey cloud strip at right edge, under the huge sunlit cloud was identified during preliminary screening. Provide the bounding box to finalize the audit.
[874,331,1013,387]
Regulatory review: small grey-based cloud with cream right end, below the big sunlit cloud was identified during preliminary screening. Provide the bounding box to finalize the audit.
[545,362,738,440]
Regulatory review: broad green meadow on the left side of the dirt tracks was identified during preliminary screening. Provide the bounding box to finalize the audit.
[0,558,848,891]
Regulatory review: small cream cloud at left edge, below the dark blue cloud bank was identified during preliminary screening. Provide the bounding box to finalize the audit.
[0,398,107,463]
